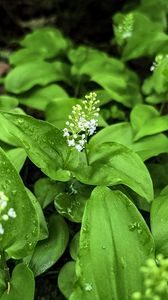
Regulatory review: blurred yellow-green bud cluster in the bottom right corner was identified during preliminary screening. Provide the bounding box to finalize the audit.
[133,254,168,300]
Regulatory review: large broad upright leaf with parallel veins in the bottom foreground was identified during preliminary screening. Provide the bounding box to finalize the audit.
[70,187,154,300]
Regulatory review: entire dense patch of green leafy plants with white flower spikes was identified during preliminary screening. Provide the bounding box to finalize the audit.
[0,0,168,300]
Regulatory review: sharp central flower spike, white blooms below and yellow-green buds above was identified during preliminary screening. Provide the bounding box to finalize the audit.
[63,92,100,152]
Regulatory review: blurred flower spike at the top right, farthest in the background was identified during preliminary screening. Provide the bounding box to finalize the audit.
[115,13,134,40]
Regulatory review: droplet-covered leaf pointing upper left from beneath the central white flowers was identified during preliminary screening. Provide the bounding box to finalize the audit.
[0,113,78,181]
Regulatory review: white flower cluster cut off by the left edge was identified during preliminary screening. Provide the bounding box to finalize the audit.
[0,191,16,235]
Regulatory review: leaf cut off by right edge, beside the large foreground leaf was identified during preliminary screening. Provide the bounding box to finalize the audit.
[150,186,168,257]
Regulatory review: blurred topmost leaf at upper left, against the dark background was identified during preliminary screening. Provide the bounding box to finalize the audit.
[21,27,68,58]
